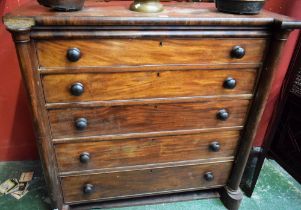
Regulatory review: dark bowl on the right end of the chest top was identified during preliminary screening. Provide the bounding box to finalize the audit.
[215,0,265,15]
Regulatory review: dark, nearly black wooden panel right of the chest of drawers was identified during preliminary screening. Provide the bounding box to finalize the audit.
[268,36,301,183]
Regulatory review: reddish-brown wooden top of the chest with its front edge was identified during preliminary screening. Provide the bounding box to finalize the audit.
[1,0,292,29]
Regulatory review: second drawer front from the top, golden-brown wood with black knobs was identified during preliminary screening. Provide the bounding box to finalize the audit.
[42,69,256,103]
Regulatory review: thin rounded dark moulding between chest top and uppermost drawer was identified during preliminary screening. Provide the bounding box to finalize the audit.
[31,29,270,39]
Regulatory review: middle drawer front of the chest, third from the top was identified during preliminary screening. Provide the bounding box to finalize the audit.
[48,100,249,138]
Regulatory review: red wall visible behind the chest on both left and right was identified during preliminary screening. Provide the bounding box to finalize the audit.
[0,0,301,161]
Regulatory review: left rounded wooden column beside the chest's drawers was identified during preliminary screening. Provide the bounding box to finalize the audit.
[6,29,63,208]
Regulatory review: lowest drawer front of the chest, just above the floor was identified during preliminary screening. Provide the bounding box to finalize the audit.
[61,162,232,203]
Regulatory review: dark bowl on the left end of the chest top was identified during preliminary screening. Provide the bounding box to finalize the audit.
[38,0,85,12]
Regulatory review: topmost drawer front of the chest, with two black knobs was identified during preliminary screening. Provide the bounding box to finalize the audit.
[36,39,267,68]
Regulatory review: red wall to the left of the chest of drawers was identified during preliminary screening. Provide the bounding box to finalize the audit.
[0,0,38,161]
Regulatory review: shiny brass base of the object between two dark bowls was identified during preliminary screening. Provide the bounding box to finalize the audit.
[130,0,163,13]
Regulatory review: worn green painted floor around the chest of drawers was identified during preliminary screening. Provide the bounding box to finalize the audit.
[0,160,301,210]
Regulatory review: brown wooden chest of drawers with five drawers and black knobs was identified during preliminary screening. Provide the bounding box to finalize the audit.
[4,1,299,209]
